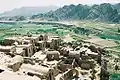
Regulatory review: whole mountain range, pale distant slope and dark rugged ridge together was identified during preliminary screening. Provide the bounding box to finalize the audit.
[0,3,120,23]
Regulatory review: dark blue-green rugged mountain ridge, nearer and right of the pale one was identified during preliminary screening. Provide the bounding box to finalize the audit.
[32,3,120,22]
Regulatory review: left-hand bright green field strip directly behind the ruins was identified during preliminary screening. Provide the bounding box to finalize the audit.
[0,23,73,40]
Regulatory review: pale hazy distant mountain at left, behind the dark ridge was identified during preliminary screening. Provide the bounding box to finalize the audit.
[0,6,59,17]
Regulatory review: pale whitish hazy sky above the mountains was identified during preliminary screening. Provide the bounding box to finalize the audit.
[0,0,120,13]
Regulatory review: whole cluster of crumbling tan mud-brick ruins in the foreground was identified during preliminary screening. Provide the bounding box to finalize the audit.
[0,34,101,80]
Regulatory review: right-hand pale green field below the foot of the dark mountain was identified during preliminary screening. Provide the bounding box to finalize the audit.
[75,20,120,42]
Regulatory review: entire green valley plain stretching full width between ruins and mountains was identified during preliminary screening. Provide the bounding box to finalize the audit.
[0,20,120,43]
